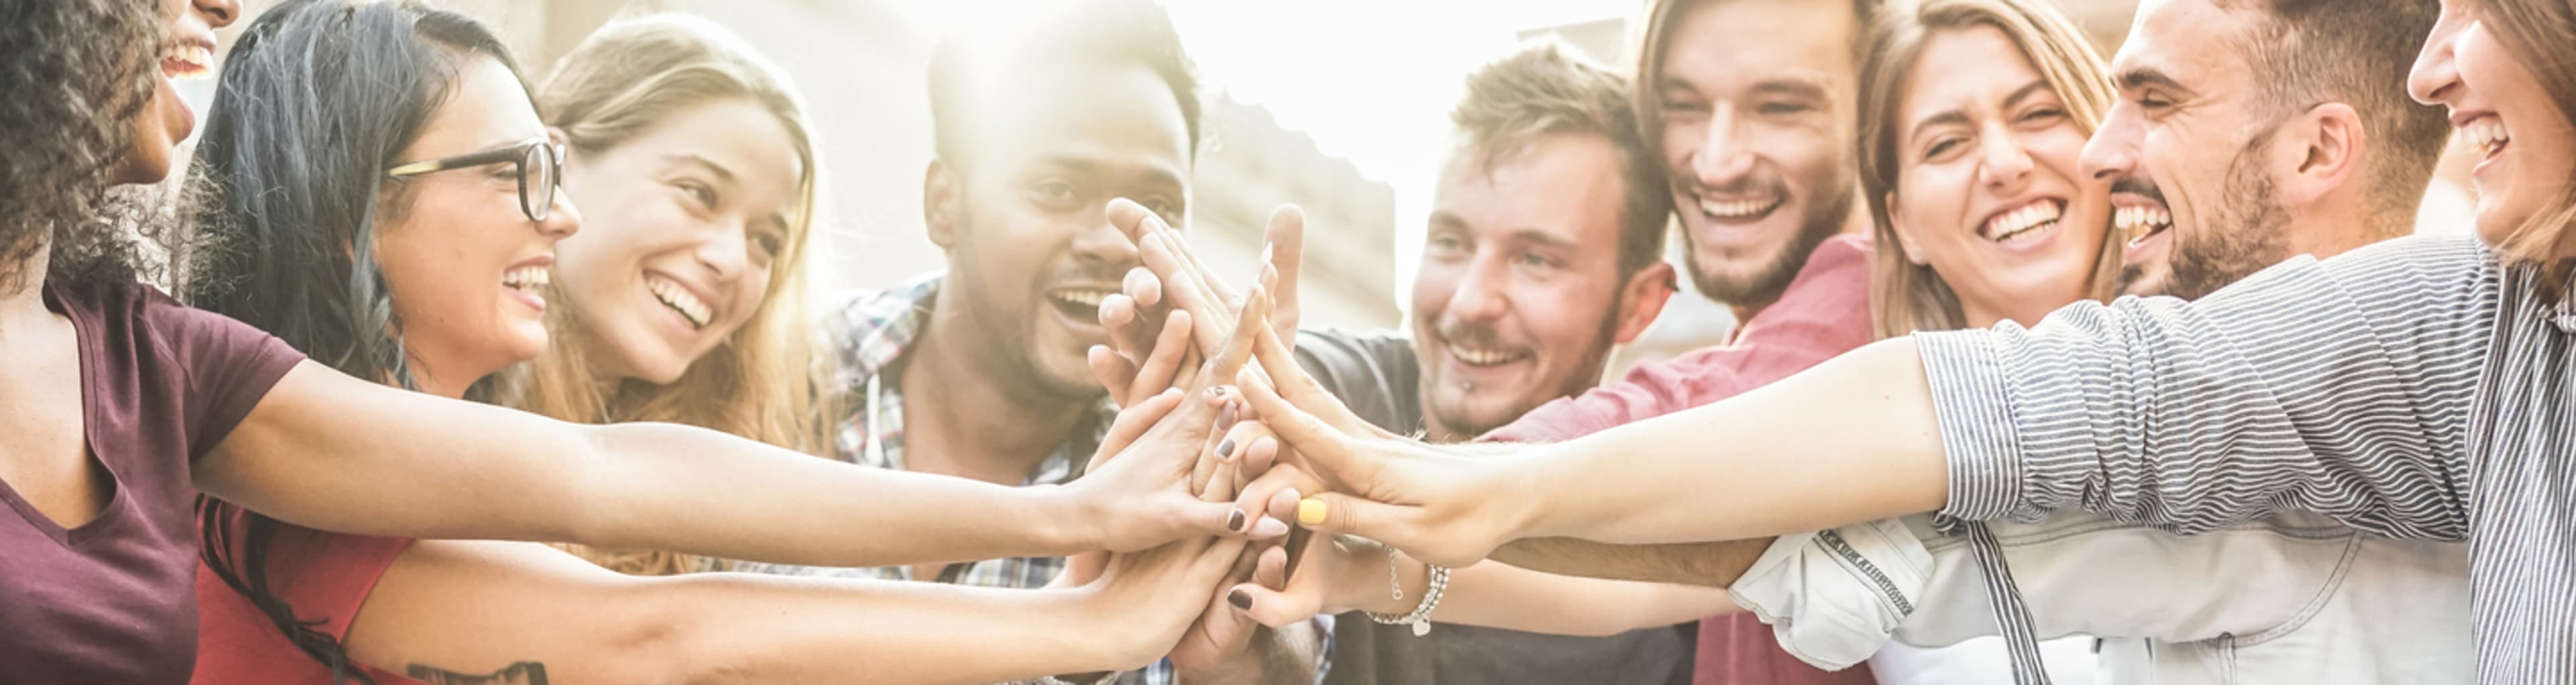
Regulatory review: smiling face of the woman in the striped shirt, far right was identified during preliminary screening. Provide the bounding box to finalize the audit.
[2406,0,2576,245]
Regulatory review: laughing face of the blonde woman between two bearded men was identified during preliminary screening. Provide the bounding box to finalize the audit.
[1888,25,2104,327]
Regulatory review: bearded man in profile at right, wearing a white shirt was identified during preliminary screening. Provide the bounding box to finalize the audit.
[1731,0,2473,682]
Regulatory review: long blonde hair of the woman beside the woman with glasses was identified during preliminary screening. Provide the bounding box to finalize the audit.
[518,13,827,574]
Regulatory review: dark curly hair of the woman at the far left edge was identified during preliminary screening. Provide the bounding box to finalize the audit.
[0,0,162,291]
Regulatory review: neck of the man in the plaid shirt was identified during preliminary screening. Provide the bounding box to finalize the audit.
[902,313,1092,484]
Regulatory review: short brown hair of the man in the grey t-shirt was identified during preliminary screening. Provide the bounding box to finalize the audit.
[1450,41,1672,278]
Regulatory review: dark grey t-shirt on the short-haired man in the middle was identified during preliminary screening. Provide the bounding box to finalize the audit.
[1296,329,1695,685]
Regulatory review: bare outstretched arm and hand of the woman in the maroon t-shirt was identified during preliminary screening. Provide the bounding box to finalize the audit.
[196,283,1288,566]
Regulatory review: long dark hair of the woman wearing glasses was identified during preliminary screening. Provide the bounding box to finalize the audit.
[180,0,525,680]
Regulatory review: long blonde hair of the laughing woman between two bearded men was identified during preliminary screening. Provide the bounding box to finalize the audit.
[1860,0,2120,337]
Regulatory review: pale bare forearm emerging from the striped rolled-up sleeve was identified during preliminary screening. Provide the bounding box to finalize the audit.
[1512,337,1947,543]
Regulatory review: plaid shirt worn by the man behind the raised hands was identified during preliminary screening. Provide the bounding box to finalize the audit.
[742,273,1175,685]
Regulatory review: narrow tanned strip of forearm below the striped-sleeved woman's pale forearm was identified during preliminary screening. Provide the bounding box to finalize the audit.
[1491,538,1770,587]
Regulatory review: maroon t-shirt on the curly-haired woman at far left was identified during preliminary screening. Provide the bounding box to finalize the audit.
[0,283,304,682]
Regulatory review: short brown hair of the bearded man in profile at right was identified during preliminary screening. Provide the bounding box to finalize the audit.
[2213,0,2450,237]
